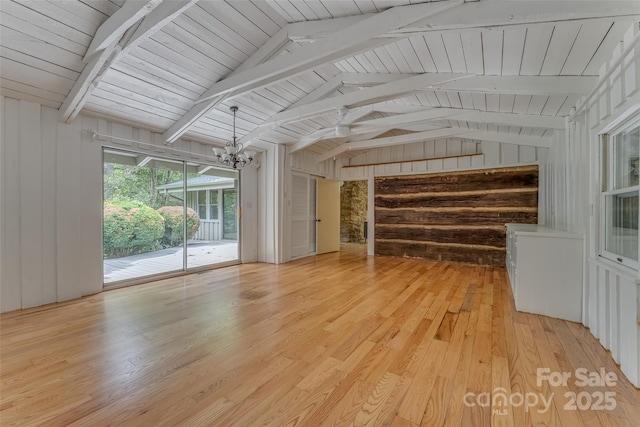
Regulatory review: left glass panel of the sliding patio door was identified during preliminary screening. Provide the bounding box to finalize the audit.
[103,150,184,285]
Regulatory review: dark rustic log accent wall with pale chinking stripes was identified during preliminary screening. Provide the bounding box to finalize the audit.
[375,165,538,266]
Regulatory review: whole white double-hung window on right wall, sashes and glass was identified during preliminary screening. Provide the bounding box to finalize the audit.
[600,115,640,268]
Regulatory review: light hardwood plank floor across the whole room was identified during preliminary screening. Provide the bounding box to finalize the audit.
[0,251,640,427]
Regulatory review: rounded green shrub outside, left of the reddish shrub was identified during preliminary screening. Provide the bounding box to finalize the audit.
[104,201,164,258]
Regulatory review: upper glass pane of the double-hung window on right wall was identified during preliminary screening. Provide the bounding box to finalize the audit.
[613,118,640,189]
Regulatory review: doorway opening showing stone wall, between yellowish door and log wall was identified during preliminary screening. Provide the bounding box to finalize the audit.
[340,180,369,254]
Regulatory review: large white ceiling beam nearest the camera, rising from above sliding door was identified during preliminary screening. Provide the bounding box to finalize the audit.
[165,0,463,142]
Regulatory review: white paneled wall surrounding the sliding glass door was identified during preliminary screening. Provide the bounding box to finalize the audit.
[0,97,257,312]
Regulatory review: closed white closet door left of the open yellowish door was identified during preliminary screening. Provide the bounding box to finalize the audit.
[291,172,316,258]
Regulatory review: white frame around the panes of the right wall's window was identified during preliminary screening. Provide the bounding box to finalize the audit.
[598,113,640,270]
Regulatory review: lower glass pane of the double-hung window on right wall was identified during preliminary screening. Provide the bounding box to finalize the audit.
[605,191,638,261]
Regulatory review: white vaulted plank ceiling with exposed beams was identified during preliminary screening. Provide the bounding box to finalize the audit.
[0,0,640,159]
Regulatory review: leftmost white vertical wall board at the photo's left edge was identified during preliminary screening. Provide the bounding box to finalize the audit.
[0,97,22,311]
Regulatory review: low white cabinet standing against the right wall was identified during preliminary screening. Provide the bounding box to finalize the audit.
[506,224,583,322]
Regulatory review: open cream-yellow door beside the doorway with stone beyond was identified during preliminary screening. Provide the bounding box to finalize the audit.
[317,178,340,254]
